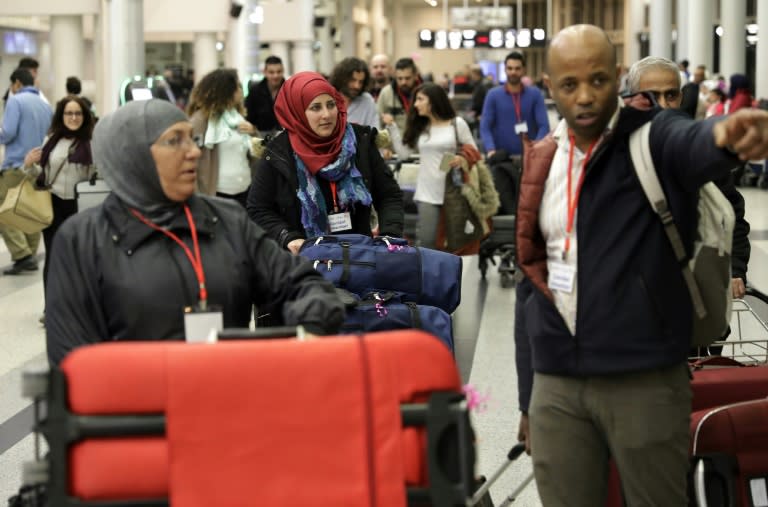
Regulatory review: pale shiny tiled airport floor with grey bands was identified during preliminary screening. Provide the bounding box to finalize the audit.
[0,189,768,507]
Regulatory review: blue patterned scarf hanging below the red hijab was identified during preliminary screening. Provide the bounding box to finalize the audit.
[293,124,372,238]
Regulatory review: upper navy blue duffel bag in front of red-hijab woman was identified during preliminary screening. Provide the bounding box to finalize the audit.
[299,234,461,313]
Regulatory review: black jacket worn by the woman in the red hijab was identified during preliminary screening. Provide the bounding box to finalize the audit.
[248,125,403,248]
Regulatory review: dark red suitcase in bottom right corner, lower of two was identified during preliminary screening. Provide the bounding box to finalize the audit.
[691,399,768,507]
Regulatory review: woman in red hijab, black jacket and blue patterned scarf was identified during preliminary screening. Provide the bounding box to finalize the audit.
[247,72,403,254]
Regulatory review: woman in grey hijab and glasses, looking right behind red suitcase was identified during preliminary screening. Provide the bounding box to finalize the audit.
[46,100,344,365]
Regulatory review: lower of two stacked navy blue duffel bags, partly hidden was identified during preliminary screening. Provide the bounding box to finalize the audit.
[337,289,453,351]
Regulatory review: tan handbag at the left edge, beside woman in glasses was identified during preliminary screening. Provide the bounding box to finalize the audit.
[0,178,53,234]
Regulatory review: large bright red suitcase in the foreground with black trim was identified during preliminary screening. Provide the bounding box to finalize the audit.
[21,330,475,507]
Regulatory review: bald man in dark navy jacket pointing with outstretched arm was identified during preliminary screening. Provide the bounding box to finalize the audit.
[517,25,768,507]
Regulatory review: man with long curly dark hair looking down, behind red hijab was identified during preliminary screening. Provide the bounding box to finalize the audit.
[328,57,379,128]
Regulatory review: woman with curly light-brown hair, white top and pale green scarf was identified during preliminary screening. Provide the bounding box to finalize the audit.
[187,69,258,207]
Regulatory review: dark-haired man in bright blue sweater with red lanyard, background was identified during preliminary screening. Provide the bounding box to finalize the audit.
[480,51,549,158]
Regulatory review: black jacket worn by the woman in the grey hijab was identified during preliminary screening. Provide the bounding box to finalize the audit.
[46,195,344,365]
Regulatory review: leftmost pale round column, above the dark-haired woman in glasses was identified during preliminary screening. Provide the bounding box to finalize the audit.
[49,16,85,99]
